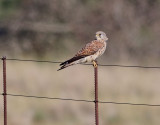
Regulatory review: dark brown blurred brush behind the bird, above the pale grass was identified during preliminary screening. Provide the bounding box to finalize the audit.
[0,0,160,61]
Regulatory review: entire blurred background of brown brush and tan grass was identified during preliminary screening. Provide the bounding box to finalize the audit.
[0,0,160,125]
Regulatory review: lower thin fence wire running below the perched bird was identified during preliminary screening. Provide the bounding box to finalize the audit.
[1,93,160,107]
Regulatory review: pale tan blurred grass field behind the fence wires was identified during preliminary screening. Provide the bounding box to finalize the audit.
[0,61,160,125]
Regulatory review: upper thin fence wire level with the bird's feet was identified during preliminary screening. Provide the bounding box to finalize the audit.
[1,58,160,69]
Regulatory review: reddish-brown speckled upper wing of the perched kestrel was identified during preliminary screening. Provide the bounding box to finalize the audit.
[75,40,104,57]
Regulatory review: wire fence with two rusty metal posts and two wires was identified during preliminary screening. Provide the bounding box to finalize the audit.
[0,56,160,125]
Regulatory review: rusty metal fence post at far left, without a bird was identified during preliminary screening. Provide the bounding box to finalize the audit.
[2,56,7,125]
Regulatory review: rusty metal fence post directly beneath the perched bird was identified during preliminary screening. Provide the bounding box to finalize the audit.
[94,62,99,125]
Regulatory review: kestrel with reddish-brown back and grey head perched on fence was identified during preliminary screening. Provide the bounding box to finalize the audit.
[57,31,108,71]
